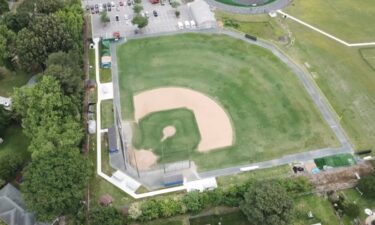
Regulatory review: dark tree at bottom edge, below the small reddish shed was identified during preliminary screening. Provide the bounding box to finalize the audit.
[89,206,125,225]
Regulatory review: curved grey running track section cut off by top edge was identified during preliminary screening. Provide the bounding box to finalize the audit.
[205,0,292,14]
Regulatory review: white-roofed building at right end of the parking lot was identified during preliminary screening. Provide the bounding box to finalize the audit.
[188,0,217,29]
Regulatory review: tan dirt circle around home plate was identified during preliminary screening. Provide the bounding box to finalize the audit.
[131,149,158,170]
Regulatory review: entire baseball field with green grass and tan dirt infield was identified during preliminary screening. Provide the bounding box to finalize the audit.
[117,34,338,170]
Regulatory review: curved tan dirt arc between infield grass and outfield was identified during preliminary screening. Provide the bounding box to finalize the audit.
[134,87,234,152]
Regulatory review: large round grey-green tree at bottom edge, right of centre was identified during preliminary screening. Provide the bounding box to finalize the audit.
[240,181,293,225]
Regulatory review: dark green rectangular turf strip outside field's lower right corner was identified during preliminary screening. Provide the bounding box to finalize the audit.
[314,154,355,169]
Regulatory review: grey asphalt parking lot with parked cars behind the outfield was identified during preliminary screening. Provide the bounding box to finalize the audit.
[83,0,193,38]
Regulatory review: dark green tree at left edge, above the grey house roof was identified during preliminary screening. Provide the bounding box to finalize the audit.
[0,151,25,181]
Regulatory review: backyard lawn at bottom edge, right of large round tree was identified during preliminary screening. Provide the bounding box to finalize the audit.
[293,194,340,225]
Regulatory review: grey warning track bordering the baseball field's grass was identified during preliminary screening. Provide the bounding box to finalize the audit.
[111,29,353,178]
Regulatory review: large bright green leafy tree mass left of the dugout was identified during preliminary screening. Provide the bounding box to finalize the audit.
[12,76,83,159]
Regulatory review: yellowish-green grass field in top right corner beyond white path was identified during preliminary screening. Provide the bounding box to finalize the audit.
[284,0,375,42]
